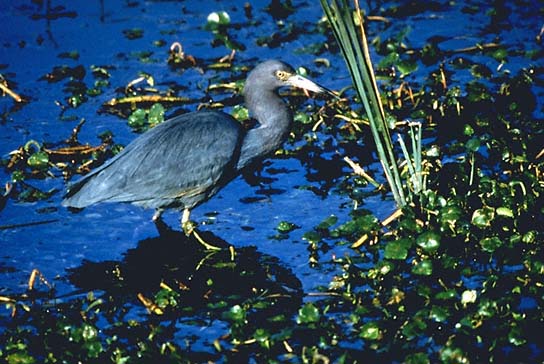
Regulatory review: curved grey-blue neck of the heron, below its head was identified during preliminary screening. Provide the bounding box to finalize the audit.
[237,90,293,169]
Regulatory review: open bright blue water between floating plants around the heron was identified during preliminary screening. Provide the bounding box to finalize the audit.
[0,0,543,362]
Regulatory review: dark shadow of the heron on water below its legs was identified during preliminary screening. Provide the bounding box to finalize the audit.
[68,220,303,317]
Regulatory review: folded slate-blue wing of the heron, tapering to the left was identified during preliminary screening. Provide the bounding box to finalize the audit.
[64,111,242,207]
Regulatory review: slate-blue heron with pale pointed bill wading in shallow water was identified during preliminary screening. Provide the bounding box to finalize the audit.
[62,60,334,248]
